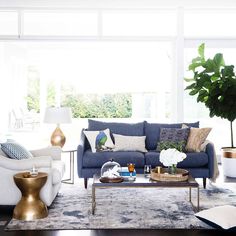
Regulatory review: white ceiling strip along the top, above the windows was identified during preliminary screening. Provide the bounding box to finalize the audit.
[0,0,236,8]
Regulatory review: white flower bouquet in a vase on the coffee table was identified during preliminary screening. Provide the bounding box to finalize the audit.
[160,148,187,174]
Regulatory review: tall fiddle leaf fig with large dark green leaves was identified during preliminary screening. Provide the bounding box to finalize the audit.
[185,44,236,147]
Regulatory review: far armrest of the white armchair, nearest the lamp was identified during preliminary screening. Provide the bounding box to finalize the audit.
[30,146,61,160]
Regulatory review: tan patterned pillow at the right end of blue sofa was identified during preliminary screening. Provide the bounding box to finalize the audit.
[182,125,212,152]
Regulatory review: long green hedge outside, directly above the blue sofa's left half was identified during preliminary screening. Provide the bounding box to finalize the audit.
[62,93,132,118]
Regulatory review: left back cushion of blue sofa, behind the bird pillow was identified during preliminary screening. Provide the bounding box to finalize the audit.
[88,119,144,136]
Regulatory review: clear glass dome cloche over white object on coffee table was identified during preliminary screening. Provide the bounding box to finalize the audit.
[101,159,121,179]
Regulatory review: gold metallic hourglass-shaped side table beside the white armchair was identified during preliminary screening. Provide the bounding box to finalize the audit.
[13,172,48,220]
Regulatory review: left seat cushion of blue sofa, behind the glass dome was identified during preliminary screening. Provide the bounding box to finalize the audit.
[83,150,144,168]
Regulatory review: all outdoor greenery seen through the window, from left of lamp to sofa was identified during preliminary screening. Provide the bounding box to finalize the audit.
[26,74,132,118]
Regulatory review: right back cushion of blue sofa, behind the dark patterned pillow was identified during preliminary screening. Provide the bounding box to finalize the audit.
[144,121,199,150]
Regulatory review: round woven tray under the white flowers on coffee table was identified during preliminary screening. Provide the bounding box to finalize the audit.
[150,168,189,182]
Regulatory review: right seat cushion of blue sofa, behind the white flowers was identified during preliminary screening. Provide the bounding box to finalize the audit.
[145,151,208,168]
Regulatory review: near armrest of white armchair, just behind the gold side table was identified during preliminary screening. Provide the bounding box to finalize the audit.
[0,156,52,171]
